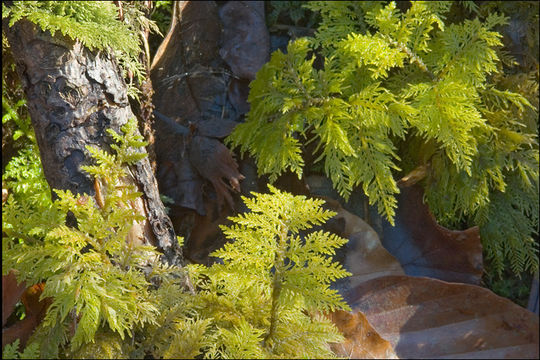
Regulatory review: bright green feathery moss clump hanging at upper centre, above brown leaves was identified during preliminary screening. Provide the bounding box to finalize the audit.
[228,38,412,222]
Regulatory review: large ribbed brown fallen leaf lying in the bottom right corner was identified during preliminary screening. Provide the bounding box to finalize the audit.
[347,275,539,359]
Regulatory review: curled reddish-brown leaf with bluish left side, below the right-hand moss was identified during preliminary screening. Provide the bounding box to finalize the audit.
[382,185,483,284]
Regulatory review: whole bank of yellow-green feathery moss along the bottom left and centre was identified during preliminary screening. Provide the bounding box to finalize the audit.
[2,120,348,358]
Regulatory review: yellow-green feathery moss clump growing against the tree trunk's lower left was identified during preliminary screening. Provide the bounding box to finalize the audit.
[2,120,161,357]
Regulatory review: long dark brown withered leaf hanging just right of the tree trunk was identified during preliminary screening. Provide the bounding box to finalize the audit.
[151,1,248,222]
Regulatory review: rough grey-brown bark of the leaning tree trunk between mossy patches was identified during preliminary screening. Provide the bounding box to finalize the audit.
[2,20,183,265]
